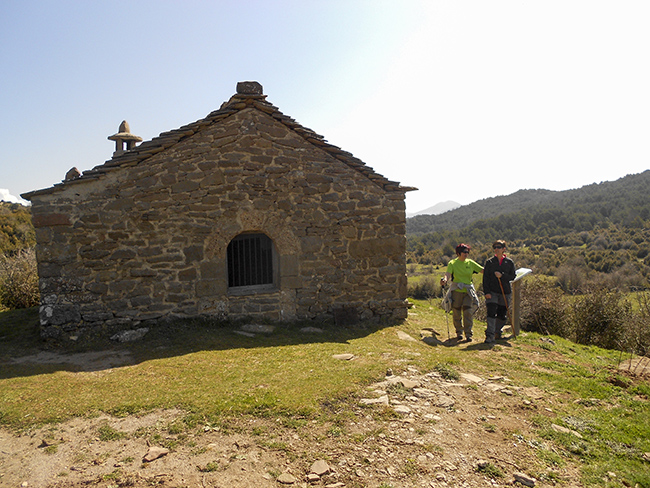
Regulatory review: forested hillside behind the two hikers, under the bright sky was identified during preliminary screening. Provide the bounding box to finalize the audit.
[407,171,650,290]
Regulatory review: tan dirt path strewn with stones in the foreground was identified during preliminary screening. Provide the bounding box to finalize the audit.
[0,358,581,488]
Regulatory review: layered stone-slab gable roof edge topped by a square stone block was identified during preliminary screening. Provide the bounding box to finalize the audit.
[21,82,417,200]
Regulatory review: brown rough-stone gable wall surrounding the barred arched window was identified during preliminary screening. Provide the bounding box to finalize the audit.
[31,97,406,337]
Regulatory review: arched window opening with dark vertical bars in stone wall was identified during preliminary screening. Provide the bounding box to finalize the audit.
[226,234,274,288]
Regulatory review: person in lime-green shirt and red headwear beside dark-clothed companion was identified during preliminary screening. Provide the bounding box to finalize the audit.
[440,244,483,342]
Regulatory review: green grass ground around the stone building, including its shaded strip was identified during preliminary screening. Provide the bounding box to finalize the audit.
[0,301,650,487]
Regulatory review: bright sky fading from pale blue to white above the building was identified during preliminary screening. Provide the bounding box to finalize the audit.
[0,0,650,213]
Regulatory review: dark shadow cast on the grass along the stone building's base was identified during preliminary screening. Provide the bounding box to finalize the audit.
[0,307,400,379]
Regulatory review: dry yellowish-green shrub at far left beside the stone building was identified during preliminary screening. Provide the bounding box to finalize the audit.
[0,249,40,310]
